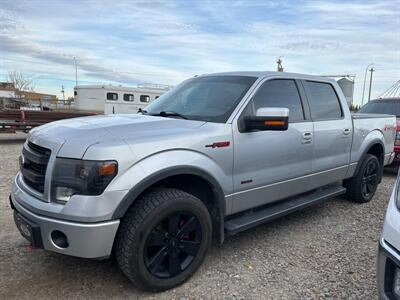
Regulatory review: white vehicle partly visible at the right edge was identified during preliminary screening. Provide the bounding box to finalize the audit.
[377,176,400,299]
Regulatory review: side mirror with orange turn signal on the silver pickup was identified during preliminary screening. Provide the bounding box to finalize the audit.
[244,107,289,131]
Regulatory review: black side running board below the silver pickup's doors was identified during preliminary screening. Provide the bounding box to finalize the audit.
[225,185,346,235]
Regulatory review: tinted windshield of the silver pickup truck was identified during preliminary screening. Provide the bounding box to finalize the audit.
[145,76,257,123]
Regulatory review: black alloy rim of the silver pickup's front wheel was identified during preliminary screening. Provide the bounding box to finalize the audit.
[144,211,202,278]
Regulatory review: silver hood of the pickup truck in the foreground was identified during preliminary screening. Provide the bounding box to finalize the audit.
[29,114,205,158]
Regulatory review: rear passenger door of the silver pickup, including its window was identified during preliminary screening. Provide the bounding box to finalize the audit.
[302,80,353,187]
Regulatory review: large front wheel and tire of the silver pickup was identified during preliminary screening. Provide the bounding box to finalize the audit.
[115,188,212,292]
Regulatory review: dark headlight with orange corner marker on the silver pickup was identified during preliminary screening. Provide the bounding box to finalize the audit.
[51,158,118,203]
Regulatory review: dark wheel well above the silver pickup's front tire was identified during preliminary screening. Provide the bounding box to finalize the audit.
[138,174,224,243]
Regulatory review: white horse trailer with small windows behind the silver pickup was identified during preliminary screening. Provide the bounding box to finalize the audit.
[74,85,169,114]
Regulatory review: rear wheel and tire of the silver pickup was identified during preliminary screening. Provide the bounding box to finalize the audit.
[344,154,382,203]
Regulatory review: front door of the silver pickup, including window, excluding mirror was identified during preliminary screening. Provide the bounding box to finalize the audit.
[232,79,313,213]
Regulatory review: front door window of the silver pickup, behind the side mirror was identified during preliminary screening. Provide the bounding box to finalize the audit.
[253,79,304,122]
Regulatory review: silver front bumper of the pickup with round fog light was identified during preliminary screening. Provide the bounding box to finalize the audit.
[10,194,119,258]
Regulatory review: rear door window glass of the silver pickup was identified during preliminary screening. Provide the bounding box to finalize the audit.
[305,81,343,121]
